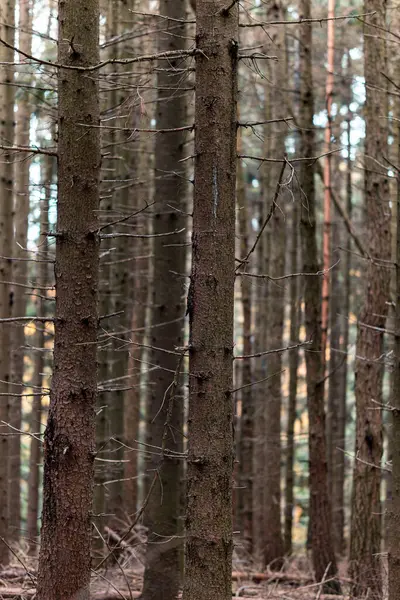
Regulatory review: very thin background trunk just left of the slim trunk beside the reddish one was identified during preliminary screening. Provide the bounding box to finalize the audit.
[284,198,300,555]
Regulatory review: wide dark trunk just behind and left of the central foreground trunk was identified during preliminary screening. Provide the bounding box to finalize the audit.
[142,0,187,600]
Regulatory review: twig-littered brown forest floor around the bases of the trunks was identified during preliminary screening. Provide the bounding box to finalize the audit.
[0,548,378,600]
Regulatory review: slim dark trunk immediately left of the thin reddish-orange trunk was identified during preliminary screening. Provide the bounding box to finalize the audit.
[299,0,340,591]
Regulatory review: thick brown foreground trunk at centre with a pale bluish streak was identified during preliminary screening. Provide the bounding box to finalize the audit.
[183,0,238,600]
